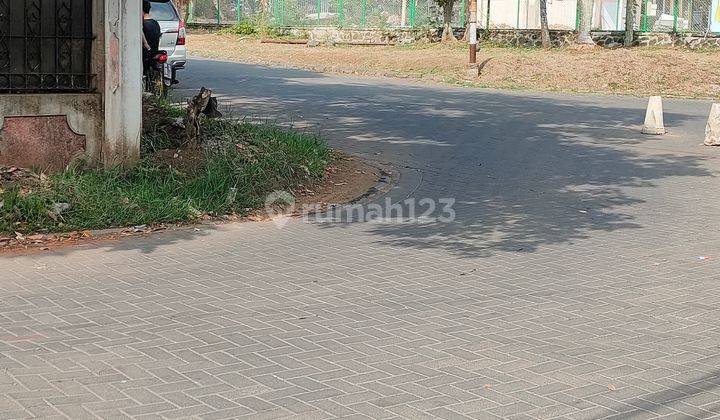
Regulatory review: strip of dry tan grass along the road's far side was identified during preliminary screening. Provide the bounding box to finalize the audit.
[188,32,720,98]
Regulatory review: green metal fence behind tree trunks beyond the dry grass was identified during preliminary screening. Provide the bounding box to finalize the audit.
[190,0,720,34]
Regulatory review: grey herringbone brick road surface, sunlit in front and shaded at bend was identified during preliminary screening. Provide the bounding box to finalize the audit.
[0,61,720,419]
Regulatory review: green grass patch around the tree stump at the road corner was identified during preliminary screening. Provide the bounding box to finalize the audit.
[0,100,330,233]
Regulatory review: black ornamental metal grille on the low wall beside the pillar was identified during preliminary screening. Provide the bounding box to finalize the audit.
[0,0,95,93]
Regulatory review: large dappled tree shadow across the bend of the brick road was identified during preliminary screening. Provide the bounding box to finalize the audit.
[181,62,712,257]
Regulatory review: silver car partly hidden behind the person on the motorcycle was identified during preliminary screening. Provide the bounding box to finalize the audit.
[150,0,187,83]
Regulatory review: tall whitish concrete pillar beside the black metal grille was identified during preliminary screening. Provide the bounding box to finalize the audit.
[100,0,142,166]
